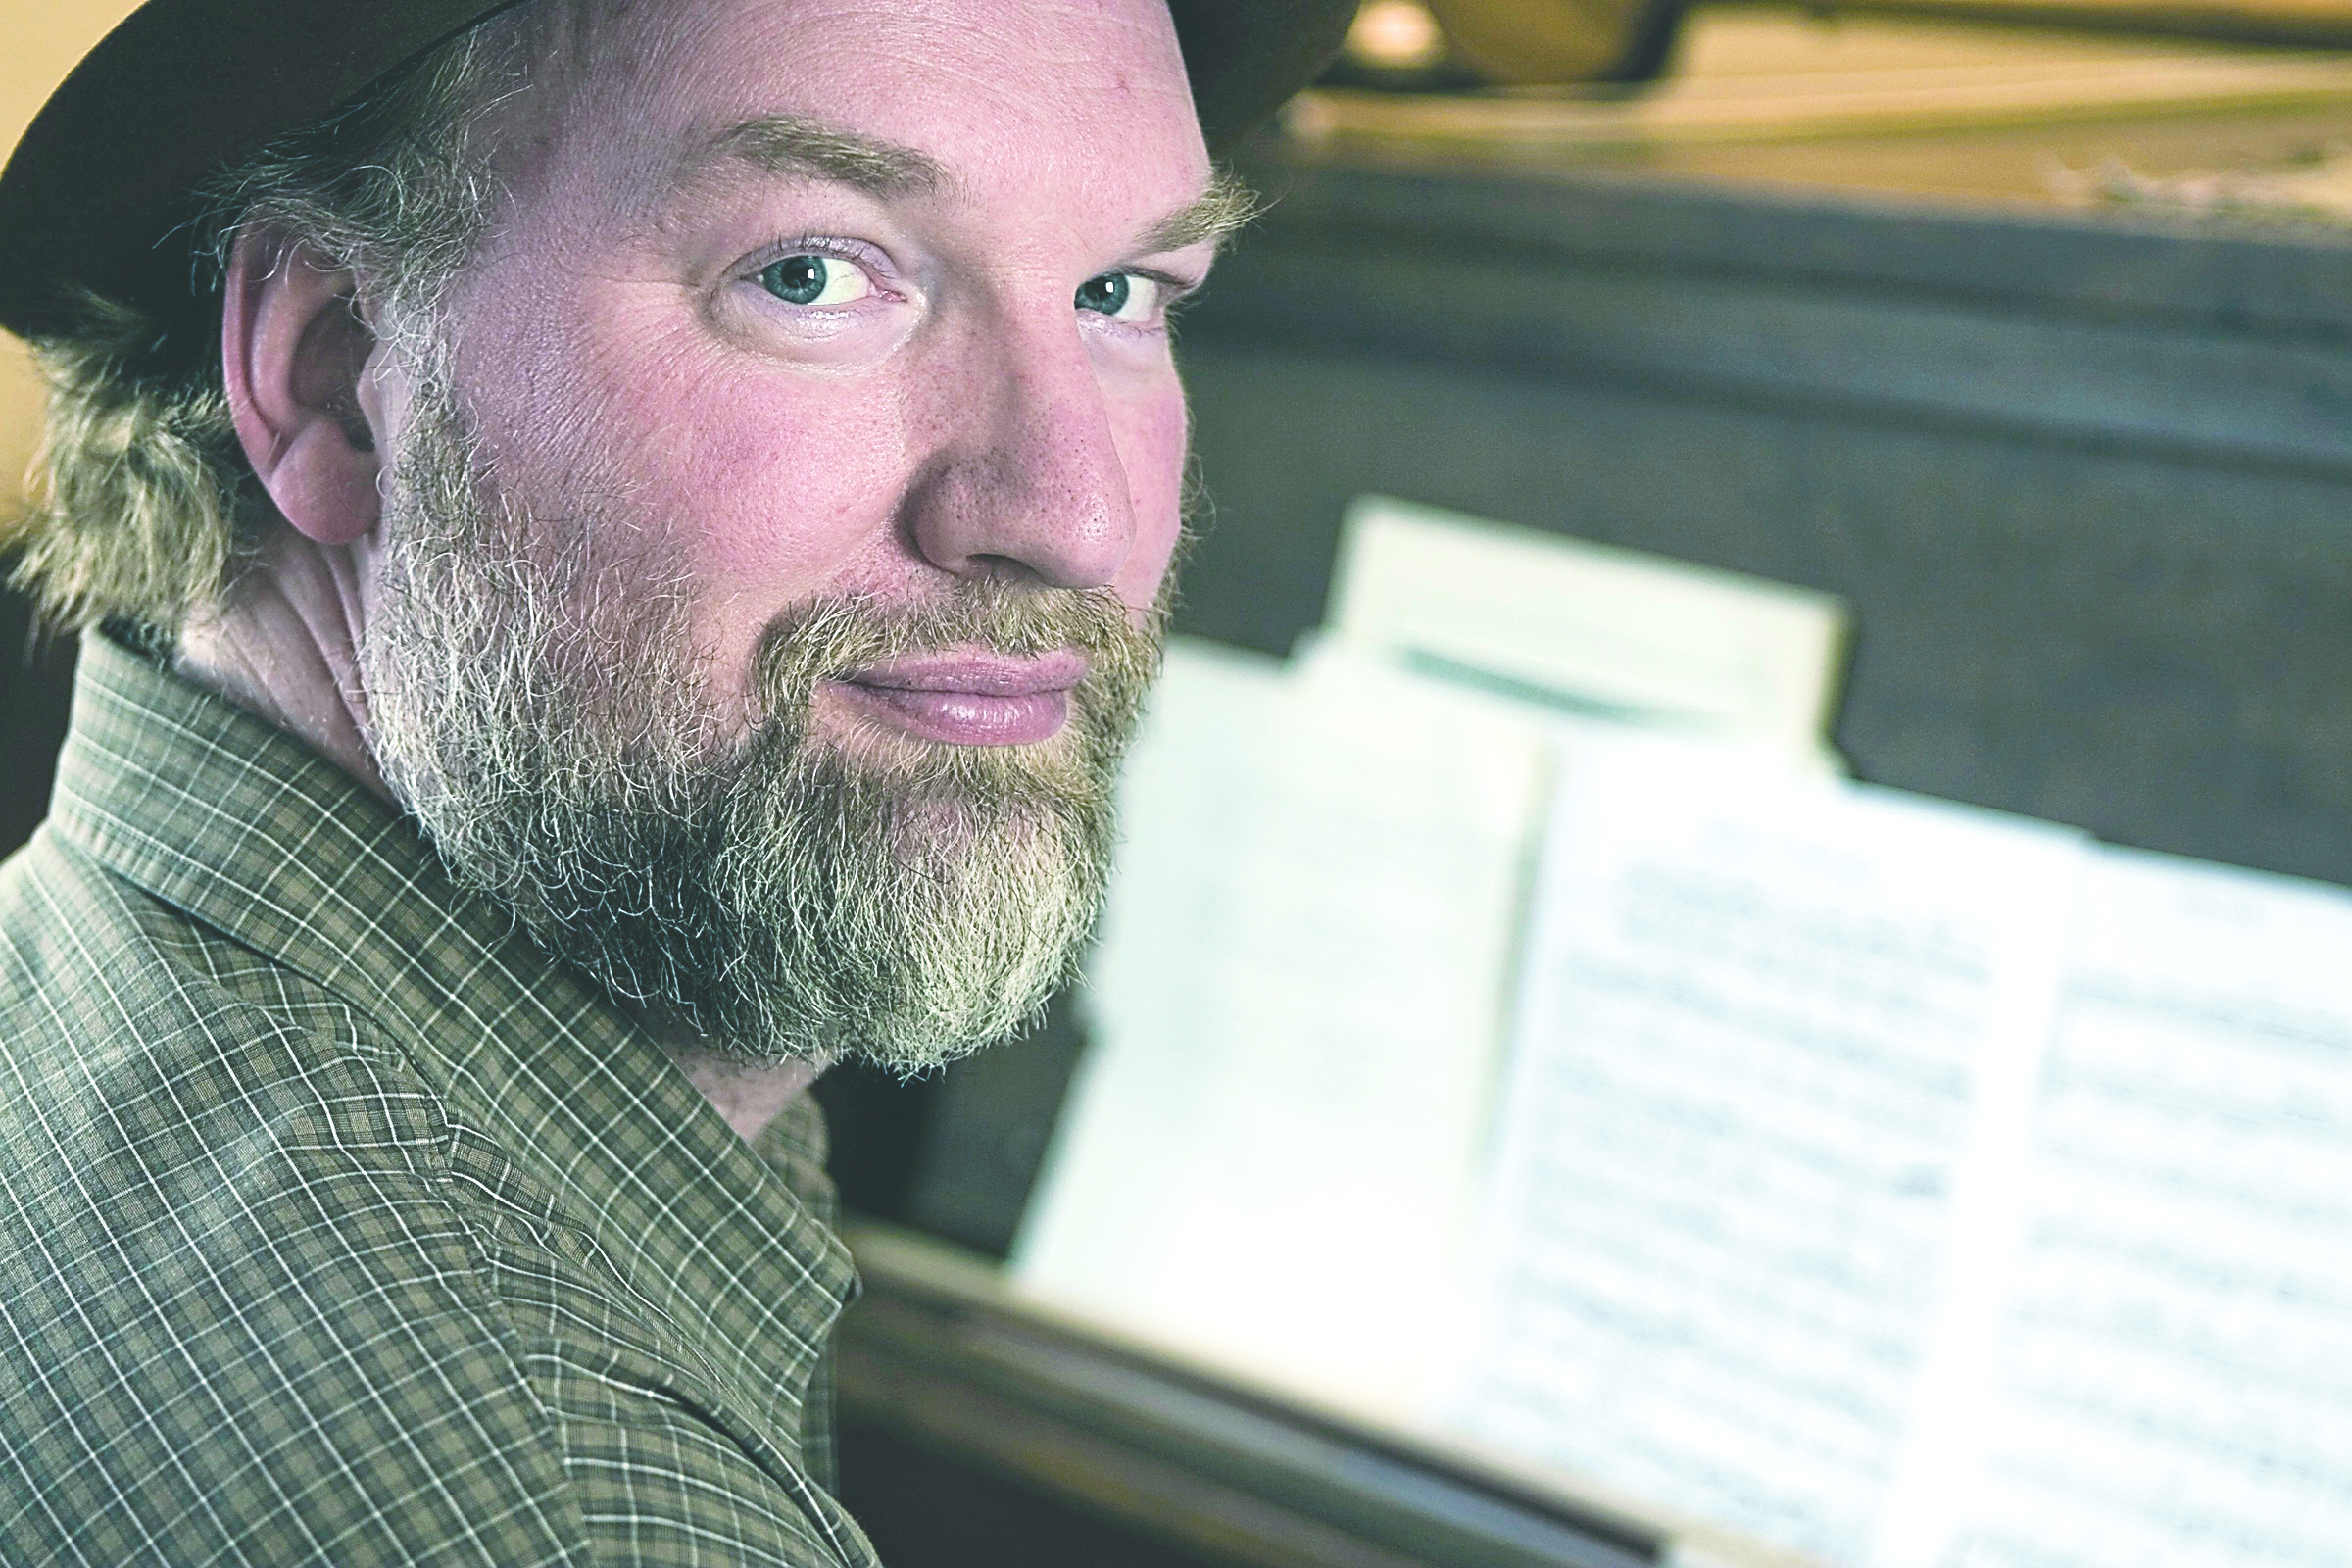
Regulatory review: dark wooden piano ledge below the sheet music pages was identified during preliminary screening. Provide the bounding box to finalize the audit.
[837,1227,1660,1568]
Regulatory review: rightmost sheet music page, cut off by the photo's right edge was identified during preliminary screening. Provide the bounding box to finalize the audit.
[1964,851,2352,1568]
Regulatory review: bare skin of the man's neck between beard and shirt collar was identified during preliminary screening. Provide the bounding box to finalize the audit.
[178,526,816,1143]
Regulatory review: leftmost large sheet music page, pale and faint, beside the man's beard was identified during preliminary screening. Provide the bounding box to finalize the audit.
[1013,642,1543,1410]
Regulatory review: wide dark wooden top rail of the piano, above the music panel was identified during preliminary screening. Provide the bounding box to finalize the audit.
[1186,167,2352,479]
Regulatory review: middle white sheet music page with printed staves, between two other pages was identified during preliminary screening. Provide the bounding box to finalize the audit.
[1445,743,2086,1568]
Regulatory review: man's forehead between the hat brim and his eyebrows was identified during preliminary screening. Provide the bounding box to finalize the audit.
[534,0,1209,207]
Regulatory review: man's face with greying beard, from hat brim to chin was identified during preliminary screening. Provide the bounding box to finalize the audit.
[365,0,1221,1067]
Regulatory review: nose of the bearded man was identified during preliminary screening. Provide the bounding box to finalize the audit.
[906,315,1136,588]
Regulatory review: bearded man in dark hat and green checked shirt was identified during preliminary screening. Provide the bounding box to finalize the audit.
[0,0,1352,1566]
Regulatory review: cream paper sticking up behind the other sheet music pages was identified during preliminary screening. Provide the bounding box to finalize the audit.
[1329,496,1846,757]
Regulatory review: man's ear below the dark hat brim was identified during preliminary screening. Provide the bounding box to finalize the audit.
[221,225,383,546]
